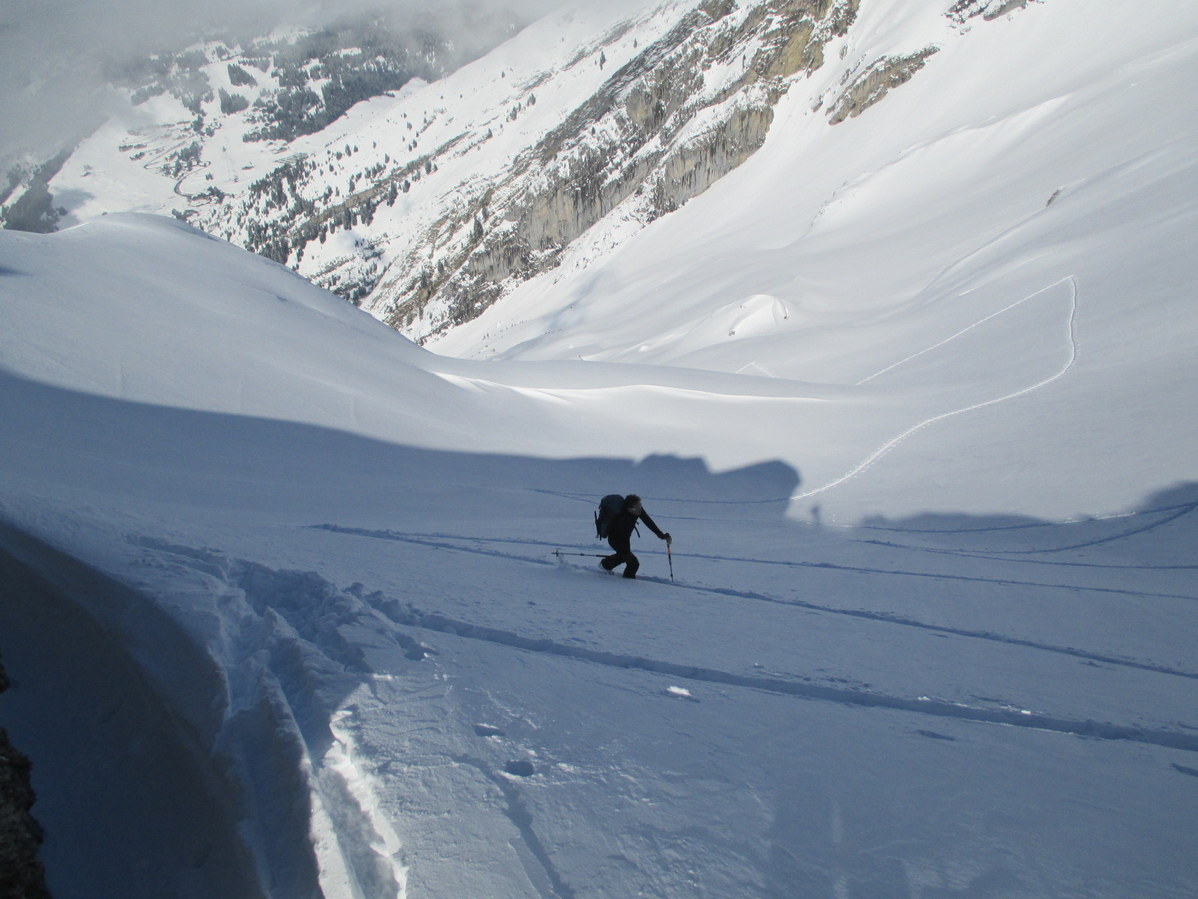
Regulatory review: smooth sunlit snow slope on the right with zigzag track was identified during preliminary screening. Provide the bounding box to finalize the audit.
[430,0,1198,521]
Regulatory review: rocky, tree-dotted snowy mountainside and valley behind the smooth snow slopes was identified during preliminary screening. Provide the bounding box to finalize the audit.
[7,0,1105,339]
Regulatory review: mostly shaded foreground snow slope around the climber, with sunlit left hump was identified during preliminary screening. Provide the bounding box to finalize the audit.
[0,217,1198,897]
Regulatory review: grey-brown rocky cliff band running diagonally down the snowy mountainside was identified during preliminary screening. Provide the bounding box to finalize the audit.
[371,0,857,339]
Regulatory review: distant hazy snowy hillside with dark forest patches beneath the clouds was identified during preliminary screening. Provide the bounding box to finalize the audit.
[0,2,526,231]
